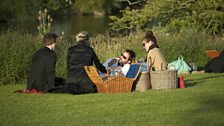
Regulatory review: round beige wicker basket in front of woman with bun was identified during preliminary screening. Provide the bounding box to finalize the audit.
[150,70,177,89]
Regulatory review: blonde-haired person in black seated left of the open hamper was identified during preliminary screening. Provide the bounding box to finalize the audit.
[52,31,106,94]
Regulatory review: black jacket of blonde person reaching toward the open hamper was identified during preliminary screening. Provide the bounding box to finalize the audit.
[66,42,106,94]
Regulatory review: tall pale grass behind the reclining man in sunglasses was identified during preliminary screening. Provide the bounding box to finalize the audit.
[91,33,146,61]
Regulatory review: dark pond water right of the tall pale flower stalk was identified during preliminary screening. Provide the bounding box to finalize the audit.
[53,15,108,35]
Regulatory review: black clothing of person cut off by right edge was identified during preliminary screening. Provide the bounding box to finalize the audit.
[205,51,224,73]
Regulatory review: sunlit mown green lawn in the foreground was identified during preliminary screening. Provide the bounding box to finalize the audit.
[0,74,224,126]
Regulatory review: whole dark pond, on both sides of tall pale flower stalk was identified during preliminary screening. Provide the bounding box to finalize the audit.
[0,15,109,36]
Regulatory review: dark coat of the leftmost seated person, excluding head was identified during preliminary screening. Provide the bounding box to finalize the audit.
[27,47,56,92]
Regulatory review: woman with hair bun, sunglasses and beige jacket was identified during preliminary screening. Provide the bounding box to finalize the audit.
[142,31,167,70]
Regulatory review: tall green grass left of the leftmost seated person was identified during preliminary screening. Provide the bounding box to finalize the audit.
[0,31,40,85]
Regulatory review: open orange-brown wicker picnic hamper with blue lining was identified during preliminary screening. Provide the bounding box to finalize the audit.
[84,64,141,93]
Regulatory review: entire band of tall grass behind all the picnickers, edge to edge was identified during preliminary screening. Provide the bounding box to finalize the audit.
[0,27,224,85]
